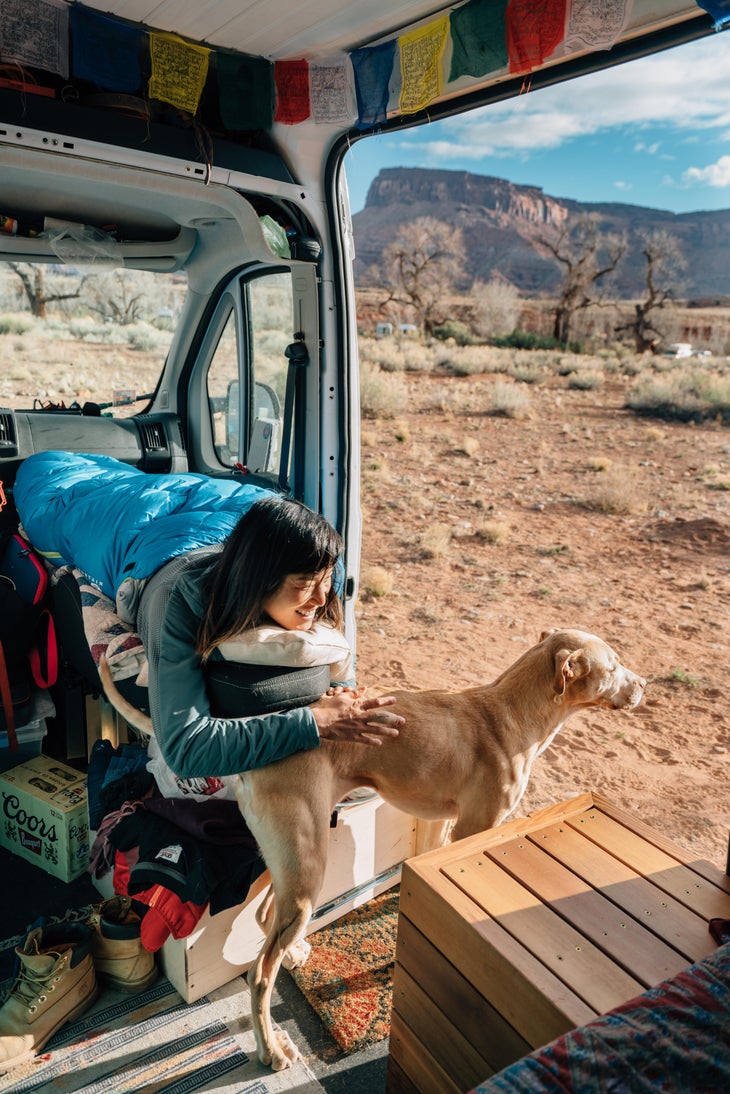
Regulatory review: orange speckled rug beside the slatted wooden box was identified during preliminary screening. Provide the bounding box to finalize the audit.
[291,889,398,1052]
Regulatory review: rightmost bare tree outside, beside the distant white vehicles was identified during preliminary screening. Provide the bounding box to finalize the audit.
[615,229,686,353]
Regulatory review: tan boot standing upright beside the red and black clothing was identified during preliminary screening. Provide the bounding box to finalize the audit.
[86,896,158,992]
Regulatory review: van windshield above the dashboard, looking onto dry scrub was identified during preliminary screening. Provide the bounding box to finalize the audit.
[0,261,181,418]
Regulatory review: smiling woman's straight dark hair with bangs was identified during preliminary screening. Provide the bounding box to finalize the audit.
[196,498,343,661]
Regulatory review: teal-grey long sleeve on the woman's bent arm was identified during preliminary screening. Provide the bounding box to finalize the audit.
[137,547,320,779]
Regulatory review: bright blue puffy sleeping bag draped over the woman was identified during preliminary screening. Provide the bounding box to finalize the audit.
[13,452,274,600]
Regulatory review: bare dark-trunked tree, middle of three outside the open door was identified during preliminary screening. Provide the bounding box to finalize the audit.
[540,214,626,346]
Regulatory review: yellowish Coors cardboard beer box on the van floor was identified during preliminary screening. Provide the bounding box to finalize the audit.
[0,756,89,882]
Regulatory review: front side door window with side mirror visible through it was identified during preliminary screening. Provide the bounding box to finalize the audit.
[207,270,294,478]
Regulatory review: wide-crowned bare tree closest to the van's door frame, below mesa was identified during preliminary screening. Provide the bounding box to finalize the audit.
[383,217,466,335]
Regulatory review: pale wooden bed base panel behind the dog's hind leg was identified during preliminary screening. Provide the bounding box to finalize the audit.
[160,798,440,1002]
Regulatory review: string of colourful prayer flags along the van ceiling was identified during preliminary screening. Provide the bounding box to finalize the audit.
[0,0,661,131]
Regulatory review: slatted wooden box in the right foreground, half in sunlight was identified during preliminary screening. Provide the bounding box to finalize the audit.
[387,793,730,1094]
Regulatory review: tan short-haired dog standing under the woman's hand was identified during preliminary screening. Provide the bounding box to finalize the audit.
[98,630,646,1070]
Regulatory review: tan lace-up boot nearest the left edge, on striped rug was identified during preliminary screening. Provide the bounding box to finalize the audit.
[0,923,99,1072]
